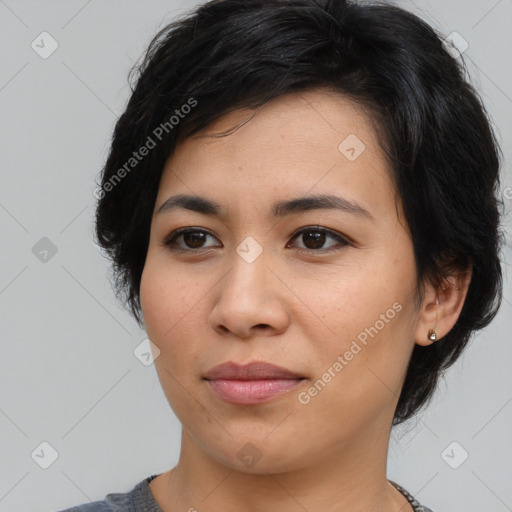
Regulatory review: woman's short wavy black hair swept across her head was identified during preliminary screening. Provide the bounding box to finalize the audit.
[95,0,503,425]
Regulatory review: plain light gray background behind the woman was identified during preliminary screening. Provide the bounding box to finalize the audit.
[0,0,512,512]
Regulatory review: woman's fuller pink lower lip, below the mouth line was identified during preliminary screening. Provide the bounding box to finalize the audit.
[208,379,303,405]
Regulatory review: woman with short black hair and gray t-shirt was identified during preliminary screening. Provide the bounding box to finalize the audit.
[61,0,502,512]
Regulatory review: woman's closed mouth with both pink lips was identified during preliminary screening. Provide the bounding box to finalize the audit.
[203,361,305,405]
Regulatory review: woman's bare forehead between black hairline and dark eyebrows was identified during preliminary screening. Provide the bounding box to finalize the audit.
[156,90,393,219]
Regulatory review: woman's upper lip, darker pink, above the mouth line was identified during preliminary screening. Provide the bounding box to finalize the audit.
[204,361,303,380]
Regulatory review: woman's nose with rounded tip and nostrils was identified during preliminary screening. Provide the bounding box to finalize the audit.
[209,251,290,338]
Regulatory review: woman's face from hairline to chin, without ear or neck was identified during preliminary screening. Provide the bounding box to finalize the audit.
[140,90,426,473]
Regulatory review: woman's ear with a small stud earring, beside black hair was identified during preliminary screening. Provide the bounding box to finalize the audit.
[414,267,472,346]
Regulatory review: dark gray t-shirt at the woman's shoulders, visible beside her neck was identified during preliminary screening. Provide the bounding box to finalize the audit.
[58,475,433,512]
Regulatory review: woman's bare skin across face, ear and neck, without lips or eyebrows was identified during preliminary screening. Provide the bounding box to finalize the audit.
[140,89,468,512]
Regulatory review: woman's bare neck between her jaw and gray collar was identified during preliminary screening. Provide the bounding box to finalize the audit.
[150,414,412,512]
